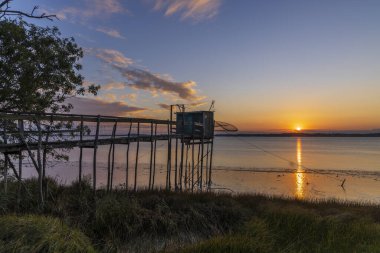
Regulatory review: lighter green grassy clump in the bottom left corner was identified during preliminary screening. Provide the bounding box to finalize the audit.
[0,215,95,253]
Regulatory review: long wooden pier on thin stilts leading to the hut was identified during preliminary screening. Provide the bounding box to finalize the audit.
[0,110,214,198]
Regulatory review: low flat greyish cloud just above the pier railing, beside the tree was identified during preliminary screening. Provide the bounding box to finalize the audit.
[67,97,147,116]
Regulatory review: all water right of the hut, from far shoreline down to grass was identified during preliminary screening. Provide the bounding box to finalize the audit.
[214,137,380,203]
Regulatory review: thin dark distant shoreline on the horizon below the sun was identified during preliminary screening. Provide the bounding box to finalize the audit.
[215,133,380,137]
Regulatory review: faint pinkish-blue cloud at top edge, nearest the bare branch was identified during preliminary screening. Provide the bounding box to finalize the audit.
[56,0,128,20]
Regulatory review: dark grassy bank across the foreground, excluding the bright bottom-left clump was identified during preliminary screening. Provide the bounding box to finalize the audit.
[0,179,380,252]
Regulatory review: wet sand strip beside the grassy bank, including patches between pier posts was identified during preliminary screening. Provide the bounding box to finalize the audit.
[24,162,380,204]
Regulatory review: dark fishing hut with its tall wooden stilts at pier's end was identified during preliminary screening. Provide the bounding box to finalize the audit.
[170,106,214,191]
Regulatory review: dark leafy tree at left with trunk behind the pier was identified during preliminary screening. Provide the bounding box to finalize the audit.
[0,19,99,202]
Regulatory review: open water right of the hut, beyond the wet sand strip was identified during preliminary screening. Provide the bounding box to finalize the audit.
[214,137,380,172]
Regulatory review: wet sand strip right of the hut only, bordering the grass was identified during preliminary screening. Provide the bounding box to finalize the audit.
[213,168,380,203]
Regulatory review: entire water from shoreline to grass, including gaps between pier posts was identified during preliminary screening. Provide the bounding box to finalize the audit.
[25,137,380,203]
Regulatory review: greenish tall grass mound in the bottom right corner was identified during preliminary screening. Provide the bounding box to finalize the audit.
[181,210,380,253]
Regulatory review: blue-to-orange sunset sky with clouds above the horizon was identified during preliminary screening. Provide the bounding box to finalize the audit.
[12,0,380,131]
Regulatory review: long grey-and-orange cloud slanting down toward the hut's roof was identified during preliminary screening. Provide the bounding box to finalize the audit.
[88,49,204,101]
